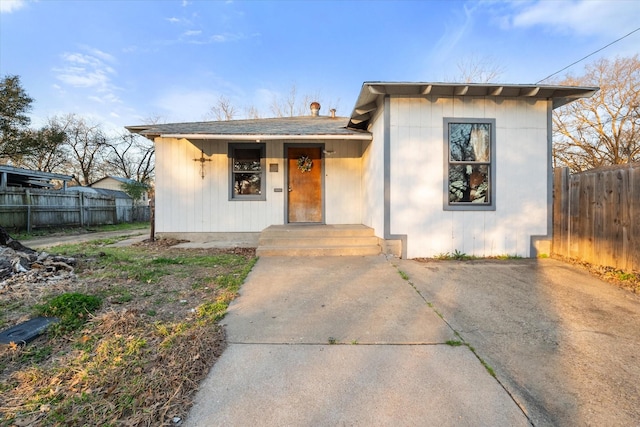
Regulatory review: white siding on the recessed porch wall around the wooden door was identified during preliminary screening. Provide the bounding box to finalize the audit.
[155,138,362,233]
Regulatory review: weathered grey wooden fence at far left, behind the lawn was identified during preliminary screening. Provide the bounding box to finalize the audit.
[0,188,118,231]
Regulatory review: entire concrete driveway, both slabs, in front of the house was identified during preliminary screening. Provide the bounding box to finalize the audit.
[186,256,640,426]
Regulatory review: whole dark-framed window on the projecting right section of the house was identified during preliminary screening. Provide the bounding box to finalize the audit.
[445,119,495,210]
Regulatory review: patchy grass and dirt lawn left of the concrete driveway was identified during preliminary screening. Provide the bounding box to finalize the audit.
[0,240,256,426]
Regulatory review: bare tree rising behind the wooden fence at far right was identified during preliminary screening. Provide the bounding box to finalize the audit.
[553,55,640,172]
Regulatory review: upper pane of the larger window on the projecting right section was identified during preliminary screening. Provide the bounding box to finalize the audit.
[449,123,491,162]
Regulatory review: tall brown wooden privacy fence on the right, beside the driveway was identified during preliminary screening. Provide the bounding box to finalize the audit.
[552,163,640,271]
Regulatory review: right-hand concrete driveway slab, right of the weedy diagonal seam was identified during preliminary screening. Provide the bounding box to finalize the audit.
[393,259,640,426]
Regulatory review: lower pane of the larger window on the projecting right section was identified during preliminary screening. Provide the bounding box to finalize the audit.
[449,164,491,203]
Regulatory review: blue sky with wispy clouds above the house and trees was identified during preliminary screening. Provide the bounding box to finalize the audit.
[0,0,640,129]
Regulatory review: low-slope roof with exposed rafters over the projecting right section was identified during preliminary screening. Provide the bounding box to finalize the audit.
[347,82,600,129]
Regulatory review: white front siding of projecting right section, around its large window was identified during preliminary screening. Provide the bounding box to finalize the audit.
[390,98,549,258]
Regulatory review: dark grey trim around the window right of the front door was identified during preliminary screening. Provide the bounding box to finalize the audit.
[443,117,497,211]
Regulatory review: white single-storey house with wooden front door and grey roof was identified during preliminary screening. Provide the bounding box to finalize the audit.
[128,82,598,258]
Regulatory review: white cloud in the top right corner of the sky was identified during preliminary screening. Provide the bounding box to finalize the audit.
[508,0,640,37]
